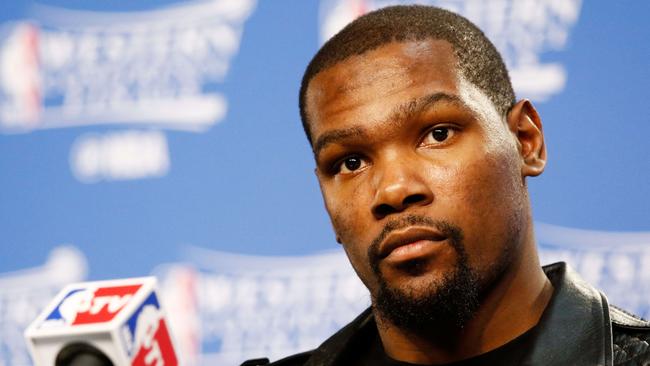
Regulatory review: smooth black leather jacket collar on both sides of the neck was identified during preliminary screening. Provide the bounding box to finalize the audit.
[305,262,613,366]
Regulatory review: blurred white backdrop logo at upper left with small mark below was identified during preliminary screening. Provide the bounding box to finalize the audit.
[0,0,255,182]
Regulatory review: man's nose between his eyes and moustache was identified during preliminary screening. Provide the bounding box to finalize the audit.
[372,158,434,220]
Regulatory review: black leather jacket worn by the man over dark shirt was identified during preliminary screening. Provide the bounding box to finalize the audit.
[242,263,650,366]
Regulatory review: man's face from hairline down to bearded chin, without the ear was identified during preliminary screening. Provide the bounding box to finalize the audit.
[306,40,528,324]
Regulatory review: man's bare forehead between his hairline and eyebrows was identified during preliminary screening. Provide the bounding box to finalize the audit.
[306,40,459,132]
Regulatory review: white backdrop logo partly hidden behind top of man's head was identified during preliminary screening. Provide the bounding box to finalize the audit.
[320,0,582,101]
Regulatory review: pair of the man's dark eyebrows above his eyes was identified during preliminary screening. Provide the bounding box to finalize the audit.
[313,92,467,158]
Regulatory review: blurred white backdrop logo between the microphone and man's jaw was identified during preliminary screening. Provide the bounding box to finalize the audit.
[155,248,370,365]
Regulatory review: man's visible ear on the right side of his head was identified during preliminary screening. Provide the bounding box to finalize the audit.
[508,99,546,177]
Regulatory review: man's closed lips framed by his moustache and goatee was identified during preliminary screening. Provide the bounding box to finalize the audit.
[379,227,447,260]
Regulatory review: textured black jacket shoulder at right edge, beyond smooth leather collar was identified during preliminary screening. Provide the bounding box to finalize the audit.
[609,305,650,366]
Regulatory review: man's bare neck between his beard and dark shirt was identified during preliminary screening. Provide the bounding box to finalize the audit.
[375,244,553,364]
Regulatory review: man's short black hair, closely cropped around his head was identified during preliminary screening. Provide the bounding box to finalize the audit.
[299,5,515,143]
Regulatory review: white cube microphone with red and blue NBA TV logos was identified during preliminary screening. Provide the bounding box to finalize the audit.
[25,277,178,366]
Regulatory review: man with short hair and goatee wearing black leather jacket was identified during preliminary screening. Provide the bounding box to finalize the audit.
[240,6,650,366]
